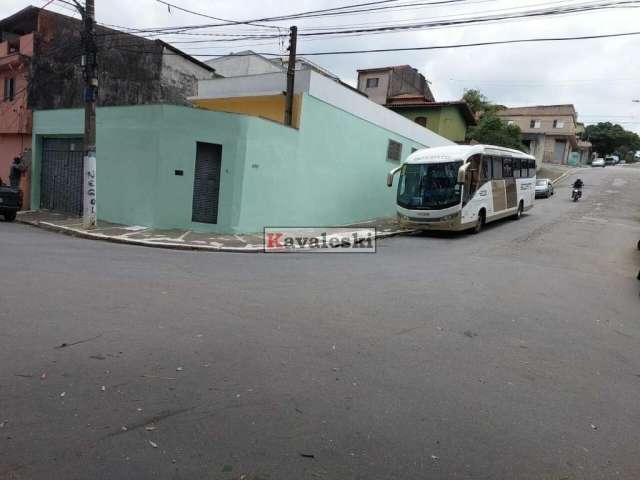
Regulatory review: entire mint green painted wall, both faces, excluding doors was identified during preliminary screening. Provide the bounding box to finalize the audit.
[32,95,424,233]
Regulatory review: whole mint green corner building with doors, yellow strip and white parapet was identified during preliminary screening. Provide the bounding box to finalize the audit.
[32,71,452,233]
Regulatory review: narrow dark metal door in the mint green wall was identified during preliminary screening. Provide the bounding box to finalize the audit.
[191,142,222,223]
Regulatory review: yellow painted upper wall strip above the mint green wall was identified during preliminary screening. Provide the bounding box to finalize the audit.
[193,95,302,128]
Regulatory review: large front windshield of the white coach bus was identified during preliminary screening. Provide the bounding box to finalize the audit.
[398,162,462,210]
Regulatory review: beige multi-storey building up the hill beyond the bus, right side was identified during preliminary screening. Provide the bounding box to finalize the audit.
[497,105,590,166]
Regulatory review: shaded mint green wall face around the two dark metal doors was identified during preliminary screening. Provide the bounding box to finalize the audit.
[32,105,250,231]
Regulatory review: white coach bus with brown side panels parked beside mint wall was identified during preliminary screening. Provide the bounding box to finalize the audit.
[387,145,536,233]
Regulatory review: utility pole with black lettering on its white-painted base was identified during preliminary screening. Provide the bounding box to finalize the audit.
[74,0,98,228]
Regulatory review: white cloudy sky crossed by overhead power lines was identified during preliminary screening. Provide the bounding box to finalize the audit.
[0,0,640,133]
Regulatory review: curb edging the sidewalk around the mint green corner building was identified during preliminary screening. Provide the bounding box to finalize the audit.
[16,216,417,253]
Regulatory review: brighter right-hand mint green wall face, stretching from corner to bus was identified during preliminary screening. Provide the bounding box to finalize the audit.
[235,94,424,230]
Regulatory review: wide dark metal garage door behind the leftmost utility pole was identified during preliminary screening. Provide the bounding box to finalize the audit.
[40,138,84,215]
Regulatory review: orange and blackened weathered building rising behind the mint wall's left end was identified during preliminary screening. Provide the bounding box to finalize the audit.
[0,7,215,208]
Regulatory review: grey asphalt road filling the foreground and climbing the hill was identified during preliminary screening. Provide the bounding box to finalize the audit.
[0,167,640,480]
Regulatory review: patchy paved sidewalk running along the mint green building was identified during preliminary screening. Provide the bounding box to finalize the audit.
[17,211,413,253]
